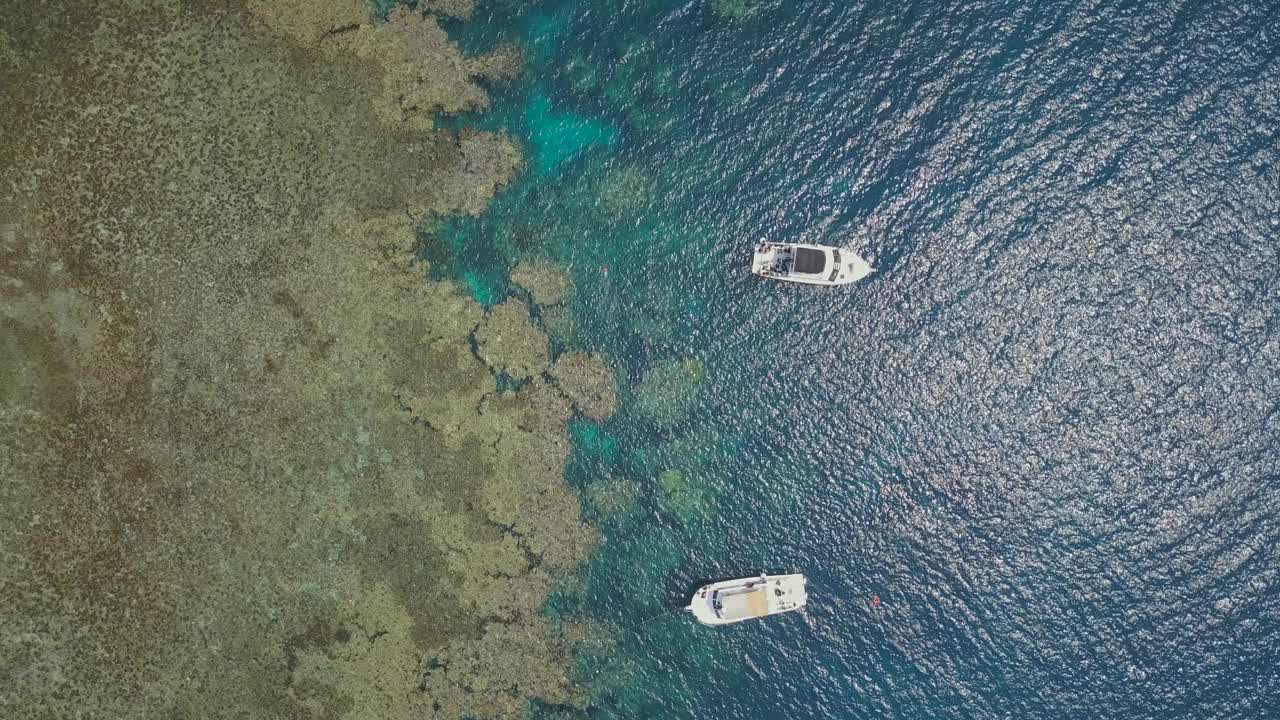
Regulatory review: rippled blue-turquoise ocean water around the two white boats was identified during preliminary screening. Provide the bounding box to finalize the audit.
[432,0,1280,720]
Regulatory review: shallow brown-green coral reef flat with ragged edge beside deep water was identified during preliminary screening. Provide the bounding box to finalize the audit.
[0,0,614,719]
